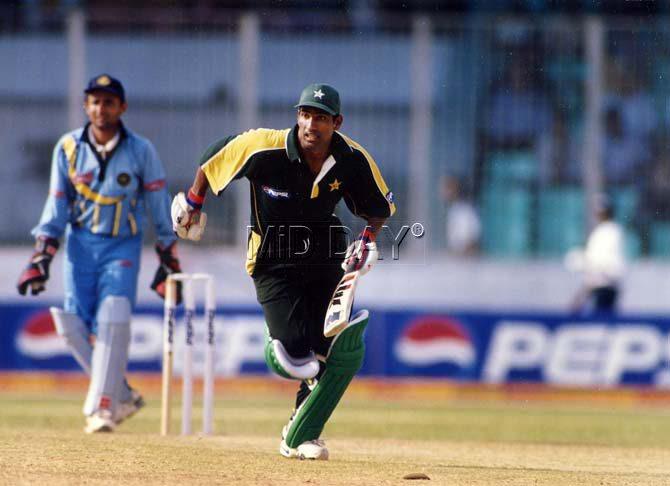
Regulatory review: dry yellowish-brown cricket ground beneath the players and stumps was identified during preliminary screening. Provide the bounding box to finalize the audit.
[0,380,670,486]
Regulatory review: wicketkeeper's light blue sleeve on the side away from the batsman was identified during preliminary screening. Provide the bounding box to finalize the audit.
[31,139,73,239]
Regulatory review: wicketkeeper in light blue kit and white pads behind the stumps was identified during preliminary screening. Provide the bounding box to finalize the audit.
[17,74,180,433]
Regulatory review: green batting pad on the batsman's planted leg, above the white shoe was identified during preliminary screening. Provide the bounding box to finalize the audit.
[285,317,368,448]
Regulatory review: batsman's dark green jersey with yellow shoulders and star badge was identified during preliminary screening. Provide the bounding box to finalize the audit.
[200,126,395,274]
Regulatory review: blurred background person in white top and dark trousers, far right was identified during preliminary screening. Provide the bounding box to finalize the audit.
[565,195,626,315]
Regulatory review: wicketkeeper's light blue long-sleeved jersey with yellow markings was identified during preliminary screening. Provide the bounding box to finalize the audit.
[32,125,176,246]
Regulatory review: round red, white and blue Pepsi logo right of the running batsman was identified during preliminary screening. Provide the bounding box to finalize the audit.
[393,316,476,367]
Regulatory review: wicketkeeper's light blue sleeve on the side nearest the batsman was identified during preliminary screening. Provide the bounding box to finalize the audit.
[142,142,177,246]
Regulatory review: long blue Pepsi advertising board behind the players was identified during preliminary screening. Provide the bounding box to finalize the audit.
[0,304,670,388]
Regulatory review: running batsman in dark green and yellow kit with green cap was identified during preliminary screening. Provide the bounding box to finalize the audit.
[172,84,395,459]
